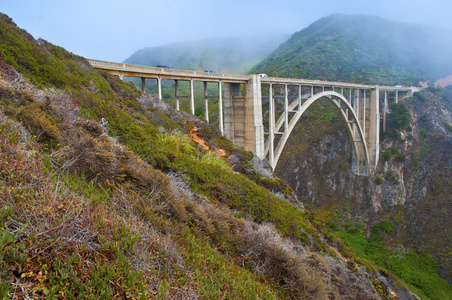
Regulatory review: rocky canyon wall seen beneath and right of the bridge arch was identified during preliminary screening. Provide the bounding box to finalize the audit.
[275,87,452,299]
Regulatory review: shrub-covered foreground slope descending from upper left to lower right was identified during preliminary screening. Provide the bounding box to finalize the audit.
[0,15,424,299]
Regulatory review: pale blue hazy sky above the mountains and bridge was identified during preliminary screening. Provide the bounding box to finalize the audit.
[0,0,452,62]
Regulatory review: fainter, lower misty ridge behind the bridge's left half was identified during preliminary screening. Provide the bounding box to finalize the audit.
[124,34,290,74]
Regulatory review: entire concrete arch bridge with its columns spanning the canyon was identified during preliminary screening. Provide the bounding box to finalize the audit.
[88,59,418,175]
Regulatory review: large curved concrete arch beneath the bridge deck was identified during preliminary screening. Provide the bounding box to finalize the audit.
[265,91,370,175]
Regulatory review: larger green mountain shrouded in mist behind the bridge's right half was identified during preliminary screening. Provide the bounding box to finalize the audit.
[250,15,452,86]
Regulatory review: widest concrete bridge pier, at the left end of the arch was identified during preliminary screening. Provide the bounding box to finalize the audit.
[224,75,265,158]
